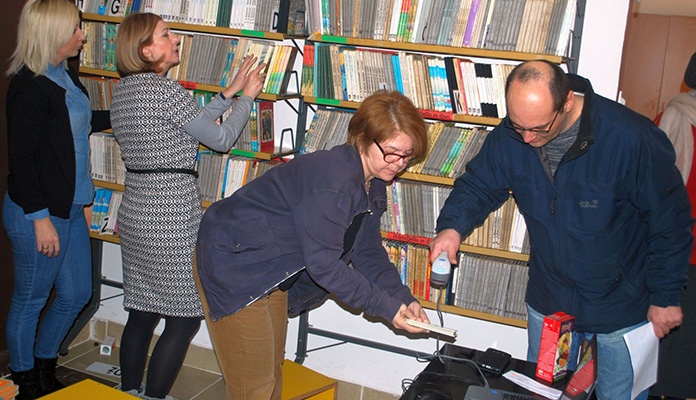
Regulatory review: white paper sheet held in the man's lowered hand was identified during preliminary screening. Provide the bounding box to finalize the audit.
[624,322,660,399]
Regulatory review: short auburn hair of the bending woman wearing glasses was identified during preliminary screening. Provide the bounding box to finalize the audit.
[347,90,428,160]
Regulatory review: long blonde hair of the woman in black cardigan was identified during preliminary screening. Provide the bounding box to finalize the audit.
[6,0,80,76]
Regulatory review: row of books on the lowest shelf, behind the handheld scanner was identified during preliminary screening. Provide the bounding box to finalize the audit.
[382,239,528,320]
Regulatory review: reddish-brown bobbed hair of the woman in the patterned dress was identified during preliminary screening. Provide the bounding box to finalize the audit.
[116,13,167,77]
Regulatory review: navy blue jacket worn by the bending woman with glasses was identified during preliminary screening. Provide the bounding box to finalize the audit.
[196,145,416,323]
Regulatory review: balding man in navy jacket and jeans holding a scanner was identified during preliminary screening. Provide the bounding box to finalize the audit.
[430,61,693,400]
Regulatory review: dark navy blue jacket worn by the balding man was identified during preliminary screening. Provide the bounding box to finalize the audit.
[437,75,693,333]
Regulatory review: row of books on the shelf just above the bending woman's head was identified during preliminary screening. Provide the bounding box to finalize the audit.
[301,43,514,118]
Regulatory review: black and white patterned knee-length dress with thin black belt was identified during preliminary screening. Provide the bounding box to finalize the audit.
[111,73,203,317]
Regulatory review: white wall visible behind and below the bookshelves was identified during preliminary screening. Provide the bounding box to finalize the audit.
[96,0,628,394]
